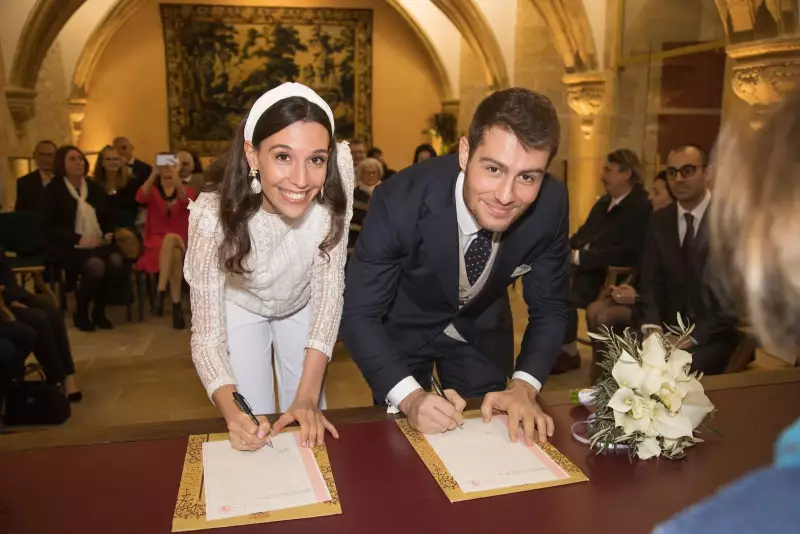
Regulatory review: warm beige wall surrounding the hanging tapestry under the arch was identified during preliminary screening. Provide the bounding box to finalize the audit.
[81,0,441,169]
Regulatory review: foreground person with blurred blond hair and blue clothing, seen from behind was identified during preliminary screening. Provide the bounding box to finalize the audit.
[654,82,800,534]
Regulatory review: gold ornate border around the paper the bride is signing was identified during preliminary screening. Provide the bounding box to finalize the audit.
[172,434,342,532]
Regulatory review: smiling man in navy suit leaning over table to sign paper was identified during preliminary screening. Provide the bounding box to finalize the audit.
[340,88,569,443]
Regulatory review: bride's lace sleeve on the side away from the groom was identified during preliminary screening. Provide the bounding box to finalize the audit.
[183,193,231,397]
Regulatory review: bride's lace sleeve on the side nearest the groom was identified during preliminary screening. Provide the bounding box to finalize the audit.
[306,142,355,359]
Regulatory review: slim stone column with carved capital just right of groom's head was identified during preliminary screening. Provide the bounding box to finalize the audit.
[564,72,609,232]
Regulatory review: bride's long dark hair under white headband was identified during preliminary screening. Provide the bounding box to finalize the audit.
[205,96,347,274]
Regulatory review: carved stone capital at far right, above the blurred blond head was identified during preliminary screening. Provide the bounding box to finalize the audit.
[726,38,800,107]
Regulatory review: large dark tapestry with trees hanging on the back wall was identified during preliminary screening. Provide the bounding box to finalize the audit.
[161,4,372,155]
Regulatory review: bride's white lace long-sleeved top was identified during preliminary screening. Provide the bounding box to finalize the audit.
[184,143,355,396]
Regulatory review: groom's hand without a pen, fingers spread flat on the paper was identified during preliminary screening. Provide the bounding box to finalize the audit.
[481,380,554,445]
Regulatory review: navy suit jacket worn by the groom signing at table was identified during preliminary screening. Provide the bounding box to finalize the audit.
[340,155,570,399]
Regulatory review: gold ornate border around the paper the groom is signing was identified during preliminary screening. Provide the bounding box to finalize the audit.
[396,411,589,502]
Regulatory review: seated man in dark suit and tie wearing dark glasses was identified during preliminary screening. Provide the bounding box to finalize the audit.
[638,145,740,374]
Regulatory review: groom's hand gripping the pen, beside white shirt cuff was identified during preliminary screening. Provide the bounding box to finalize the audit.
[399,389,467,434]
